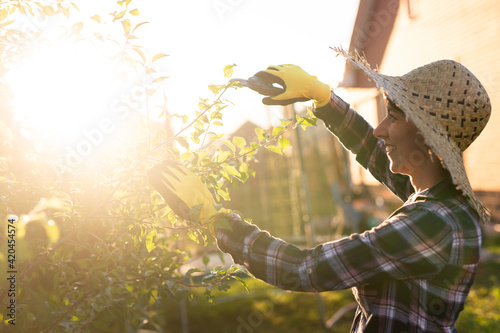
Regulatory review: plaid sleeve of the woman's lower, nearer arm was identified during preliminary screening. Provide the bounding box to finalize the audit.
[217,209,452,292]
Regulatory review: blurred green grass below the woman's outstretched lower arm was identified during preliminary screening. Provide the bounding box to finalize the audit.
[165,278,354,333]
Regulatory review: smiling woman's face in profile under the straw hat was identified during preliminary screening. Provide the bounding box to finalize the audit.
[373,100,430,176]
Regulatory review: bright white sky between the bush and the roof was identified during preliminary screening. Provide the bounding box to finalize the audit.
[81,0,359,131]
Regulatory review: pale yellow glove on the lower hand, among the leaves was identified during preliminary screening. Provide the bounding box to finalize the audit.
[148,161,229,235]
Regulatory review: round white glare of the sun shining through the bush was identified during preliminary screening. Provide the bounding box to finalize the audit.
[7,43,114,140]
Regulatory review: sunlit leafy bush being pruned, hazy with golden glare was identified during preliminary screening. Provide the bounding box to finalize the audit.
[0,0,315,332]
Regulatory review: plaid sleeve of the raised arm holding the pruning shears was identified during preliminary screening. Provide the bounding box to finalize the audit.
[315,92,414,201]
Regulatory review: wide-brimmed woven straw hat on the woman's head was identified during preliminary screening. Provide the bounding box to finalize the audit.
[334,48,491,222]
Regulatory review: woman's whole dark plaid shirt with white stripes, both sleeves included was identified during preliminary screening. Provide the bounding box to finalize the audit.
[217,94,481,333]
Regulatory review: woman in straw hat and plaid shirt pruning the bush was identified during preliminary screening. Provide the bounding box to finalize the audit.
[149,50,491,333]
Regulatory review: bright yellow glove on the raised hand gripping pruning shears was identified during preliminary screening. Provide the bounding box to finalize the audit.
[249,65,331,107]
